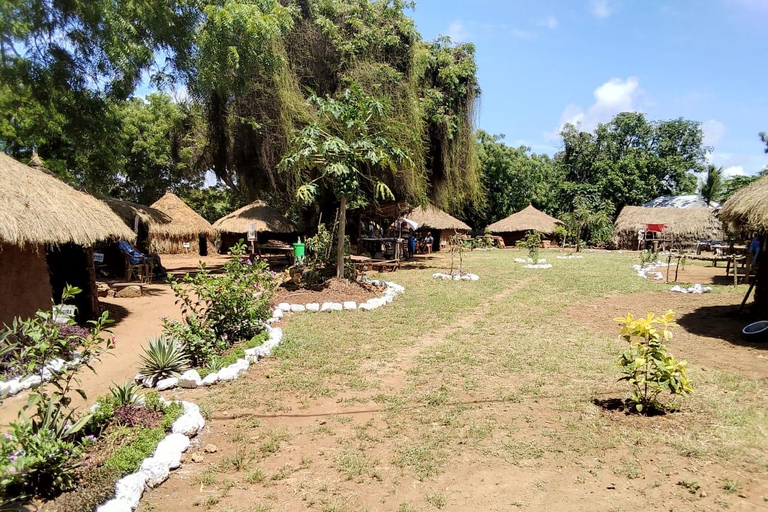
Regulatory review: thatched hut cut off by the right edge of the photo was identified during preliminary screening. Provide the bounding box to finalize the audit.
[720,176,768,319]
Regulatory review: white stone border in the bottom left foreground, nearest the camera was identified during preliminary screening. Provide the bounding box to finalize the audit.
[96,398,205,512]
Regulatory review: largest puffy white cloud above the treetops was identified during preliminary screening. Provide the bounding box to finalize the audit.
[545,76,643,139]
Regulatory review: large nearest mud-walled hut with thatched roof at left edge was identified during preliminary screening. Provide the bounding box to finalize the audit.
[0,153,134,323]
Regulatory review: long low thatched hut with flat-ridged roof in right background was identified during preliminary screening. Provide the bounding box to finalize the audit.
[612,206,723,250]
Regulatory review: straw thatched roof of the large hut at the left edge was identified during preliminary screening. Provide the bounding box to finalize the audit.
[0,153,135,246]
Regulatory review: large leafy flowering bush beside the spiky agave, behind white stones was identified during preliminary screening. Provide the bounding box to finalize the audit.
[169,243,276,344]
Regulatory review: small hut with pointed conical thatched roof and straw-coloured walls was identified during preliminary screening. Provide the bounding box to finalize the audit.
[149,192,216,256]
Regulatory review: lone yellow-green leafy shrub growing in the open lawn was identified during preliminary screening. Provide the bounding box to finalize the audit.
[615,311,693,414]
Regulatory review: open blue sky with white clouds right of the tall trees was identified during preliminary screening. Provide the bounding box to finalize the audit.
[411,0,768,175]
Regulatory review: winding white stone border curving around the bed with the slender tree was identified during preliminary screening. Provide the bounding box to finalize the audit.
[140,276,405,391]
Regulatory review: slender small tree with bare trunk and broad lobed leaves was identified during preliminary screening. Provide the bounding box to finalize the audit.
[279,87,412,278]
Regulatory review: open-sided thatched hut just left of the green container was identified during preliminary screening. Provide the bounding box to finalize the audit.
[213,201,296,252]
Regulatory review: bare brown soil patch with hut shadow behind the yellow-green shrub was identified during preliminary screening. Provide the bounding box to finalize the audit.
[565,292,768,379]
